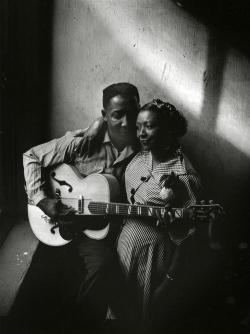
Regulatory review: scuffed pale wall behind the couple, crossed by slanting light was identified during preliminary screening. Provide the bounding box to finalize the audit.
[50,0,250,222]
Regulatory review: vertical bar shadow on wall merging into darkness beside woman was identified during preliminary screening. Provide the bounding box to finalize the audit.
[184,31,250,219]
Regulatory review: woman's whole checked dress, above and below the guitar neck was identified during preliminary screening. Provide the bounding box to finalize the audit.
[117,149,200,321]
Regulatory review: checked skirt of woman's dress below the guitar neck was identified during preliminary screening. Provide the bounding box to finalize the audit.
[117,218,174,321]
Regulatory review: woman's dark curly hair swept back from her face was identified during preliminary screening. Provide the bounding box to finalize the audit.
[140,99,187,138]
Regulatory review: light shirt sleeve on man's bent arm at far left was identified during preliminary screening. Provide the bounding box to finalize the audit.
[23,134,82,205]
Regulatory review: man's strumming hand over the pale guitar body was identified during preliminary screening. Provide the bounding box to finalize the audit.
[37,197,75,220]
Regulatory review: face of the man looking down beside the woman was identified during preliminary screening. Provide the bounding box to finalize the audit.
[102,95,139,143]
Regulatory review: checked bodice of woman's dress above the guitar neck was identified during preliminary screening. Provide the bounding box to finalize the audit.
[125,149,200,207]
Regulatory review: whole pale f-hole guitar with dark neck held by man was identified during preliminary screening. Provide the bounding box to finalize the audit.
[28,164,223,246]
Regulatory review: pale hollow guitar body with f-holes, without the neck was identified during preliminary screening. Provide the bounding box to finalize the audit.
[28,164,119,246]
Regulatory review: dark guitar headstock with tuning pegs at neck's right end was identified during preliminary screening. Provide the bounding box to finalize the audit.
[184,200,225,222]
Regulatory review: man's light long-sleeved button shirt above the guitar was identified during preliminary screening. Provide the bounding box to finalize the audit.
[23,130,137,204]
